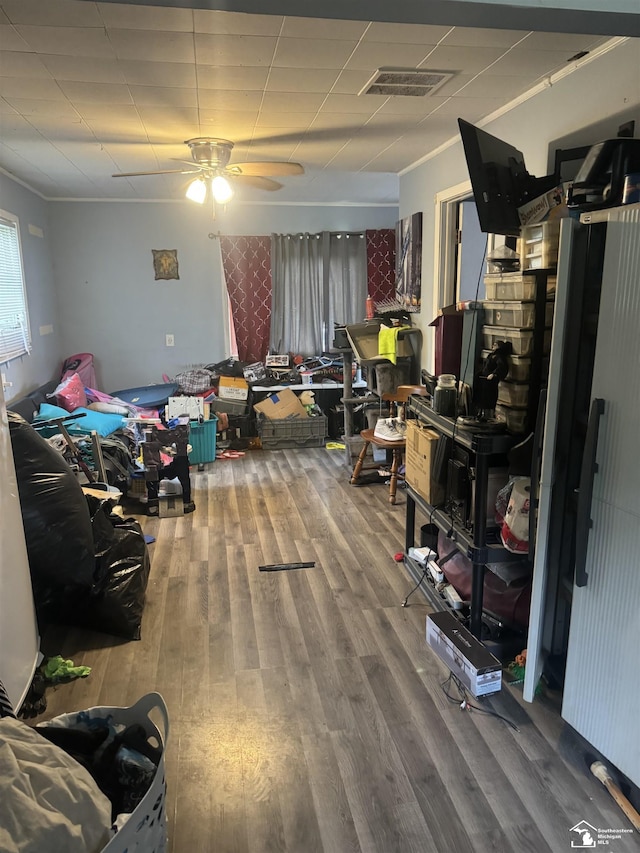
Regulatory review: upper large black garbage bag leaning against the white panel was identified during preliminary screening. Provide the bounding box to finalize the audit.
[7,411,94,588]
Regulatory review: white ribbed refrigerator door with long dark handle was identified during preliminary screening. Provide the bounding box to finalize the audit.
[562,209,640,785]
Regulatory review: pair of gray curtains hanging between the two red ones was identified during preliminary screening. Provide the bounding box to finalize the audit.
[269,231,367,356]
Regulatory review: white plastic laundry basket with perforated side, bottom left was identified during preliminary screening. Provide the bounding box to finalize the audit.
[39,693,169,853]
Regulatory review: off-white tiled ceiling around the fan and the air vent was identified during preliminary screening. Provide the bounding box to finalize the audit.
[0,0,628,204]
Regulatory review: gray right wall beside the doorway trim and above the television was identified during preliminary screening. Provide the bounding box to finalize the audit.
[400,40,640,367]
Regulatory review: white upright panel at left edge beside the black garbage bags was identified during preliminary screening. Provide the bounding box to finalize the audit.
[0,383,39,710]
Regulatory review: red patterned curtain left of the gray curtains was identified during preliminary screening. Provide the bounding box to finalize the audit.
[220,237,271,362]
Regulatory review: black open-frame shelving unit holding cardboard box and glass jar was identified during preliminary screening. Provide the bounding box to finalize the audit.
[405,397,522,639]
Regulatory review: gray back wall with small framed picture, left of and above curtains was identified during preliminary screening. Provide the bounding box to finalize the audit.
[50,201,398,392]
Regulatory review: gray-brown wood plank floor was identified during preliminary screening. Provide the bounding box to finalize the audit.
[37,448,637,853]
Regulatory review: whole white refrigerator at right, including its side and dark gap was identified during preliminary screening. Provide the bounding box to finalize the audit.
[524,204,640,785]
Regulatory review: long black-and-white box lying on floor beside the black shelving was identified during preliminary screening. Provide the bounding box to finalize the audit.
[426,610,502,698]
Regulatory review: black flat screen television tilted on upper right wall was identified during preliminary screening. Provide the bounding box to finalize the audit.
[458,118,558,237]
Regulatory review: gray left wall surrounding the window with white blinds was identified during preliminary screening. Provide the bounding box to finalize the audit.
[0,173,65,402]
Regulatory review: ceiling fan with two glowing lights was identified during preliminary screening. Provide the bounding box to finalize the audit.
[112,136,304,204]
